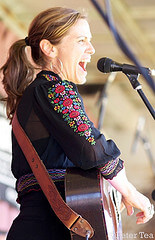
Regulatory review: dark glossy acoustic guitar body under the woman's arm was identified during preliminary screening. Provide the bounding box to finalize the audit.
[65,168,122,240]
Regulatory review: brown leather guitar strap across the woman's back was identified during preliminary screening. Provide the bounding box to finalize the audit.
[12,113,94,238]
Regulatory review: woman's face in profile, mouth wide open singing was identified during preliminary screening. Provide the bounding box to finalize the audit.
[55,19,95,84]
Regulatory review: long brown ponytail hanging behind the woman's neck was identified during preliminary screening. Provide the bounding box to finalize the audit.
[0,39,34,120]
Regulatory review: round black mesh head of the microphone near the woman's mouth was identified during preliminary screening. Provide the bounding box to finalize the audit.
[97,58,113,73]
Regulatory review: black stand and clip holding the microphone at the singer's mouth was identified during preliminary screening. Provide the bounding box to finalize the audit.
[124,73,155,119]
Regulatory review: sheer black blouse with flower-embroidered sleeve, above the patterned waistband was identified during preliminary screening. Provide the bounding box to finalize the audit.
[12,71,123,179]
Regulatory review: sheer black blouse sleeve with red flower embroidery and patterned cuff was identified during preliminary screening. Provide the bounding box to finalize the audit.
[35,75,123,178]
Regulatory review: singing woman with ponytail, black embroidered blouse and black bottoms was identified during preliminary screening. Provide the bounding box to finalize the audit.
[2,8,154,240]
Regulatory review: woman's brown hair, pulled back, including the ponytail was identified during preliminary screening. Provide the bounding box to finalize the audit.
[1,7,86,120]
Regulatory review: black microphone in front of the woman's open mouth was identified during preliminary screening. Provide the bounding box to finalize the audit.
[97,58,155,75]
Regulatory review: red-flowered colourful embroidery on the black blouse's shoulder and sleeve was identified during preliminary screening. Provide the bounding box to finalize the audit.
[43,74,96,145]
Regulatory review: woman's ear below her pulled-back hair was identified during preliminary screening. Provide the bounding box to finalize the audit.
[39,39,56,58]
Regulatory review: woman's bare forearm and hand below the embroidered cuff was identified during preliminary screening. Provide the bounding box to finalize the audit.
[108,169,154,224]
